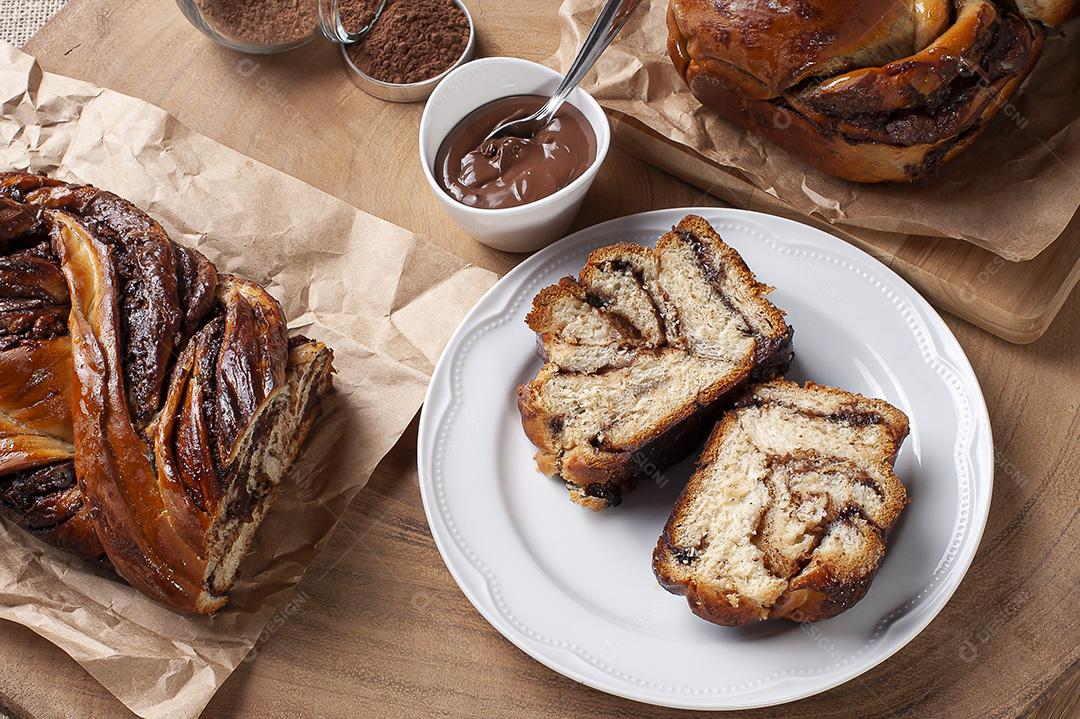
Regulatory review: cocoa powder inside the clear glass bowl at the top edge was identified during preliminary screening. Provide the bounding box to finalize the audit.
[195,0,318,45]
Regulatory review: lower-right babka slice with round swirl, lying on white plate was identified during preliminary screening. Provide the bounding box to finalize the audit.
[652,380,908,626]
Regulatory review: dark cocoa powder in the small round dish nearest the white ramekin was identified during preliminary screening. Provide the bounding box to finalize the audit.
[341,0,469,84]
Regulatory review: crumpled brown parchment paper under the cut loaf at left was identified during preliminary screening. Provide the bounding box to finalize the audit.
[0,44,496,718]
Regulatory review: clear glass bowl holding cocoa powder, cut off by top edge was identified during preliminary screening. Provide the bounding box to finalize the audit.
[176,0,319,55]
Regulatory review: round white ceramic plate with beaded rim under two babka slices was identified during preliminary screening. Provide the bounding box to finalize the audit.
[418,208,993,709]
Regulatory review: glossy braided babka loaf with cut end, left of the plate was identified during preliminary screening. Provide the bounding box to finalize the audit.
[0,173,333,613]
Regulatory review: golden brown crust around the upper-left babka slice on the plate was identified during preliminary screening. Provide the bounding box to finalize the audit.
[517,215,791,510]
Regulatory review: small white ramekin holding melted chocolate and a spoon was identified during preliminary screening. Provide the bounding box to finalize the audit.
[420,57,611,253]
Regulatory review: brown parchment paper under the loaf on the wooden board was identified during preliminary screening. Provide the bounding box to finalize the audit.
[549,0,1080,261]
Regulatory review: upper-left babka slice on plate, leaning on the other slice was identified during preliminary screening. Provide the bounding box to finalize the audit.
[518,215,792,510]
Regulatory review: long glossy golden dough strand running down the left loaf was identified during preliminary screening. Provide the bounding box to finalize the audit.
[53,212,211,611]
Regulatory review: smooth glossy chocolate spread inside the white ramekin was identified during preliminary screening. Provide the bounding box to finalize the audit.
[435,95,596,209]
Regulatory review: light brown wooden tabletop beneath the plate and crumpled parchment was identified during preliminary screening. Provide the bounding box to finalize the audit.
[0,0,1080,719]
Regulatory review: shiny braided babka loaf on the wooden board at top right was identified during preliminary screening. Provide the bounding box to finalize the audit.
[667,0,1080,182]
